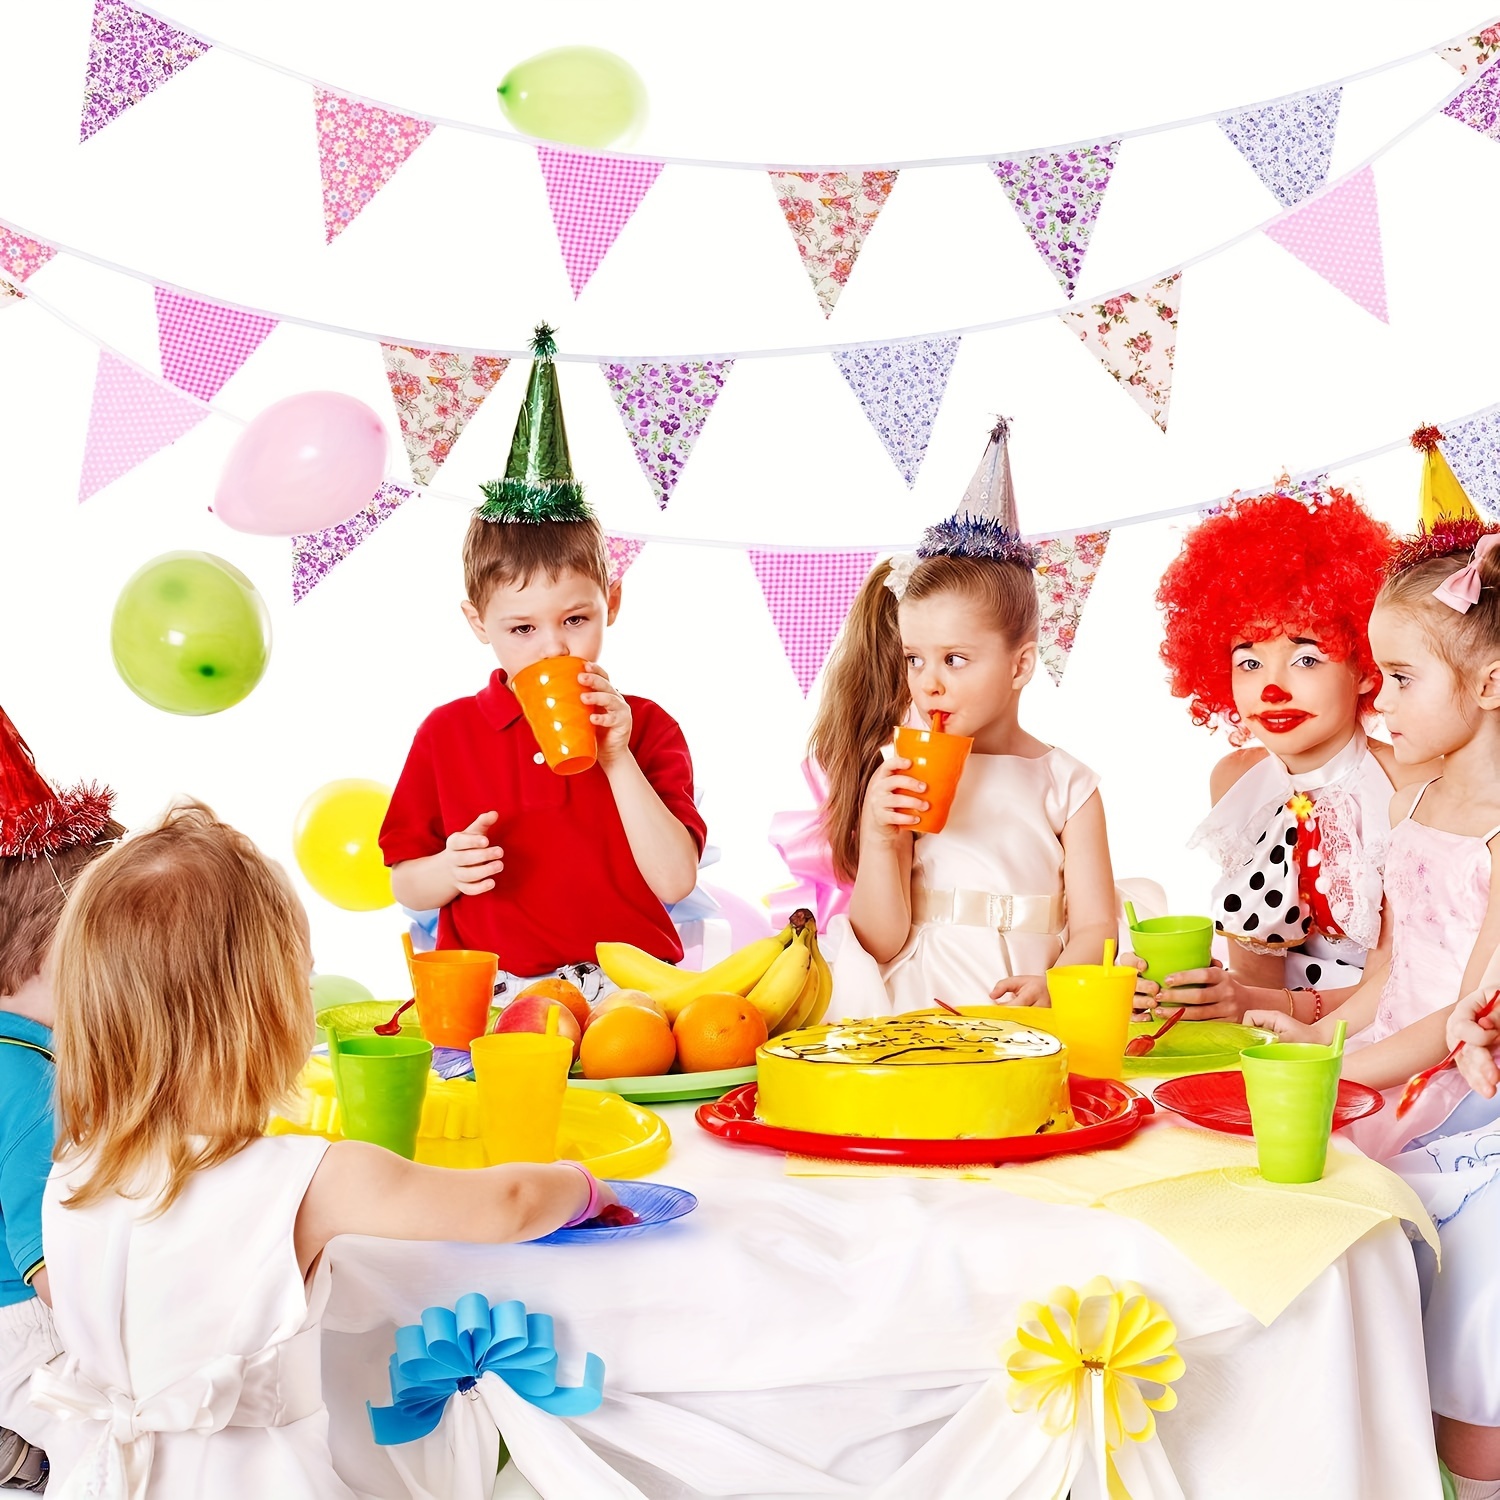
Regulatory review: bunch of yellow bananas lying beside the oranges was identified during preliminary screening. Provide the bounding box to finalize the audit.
[597,908,834,1037]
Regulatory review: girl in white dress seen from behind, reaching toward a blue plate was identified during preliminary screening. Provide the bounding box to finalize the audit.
[32,804,605,1500]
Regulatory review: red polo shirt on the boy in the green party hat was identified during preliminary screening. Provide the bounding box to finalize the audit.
[380,671,707,974]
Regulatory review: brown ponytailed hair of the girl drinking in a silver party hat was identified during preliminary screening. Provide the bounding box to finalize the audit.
[807,555,1041,881]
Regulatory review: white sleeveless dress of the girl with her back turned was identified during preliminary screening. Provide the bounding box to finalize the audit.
[32,1136,354,1500]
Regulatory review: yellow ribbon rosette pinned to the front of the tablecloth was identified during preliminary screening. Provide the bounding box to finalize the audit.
[1001,1277,1187,1488]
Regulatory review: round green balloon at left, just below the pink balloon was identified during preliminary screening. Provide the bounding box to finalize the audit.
[110,552,272,714]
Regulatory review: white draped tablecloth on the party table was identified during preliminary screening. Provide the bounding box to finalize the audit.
[324,1106,1442,1500]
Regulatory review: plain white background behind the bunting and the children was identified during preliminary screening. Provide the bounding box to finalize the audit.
[0,0,1500,995]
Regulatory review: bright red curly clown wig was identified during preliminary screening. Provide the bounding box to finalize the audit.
[1157,489,1395,725]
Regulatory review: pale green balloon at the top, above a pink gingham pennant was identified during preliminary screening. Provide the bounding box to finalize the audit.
[498,47,647,150]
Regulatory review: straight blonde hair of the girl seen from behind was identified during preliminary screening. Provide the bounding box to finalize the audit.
[54,803,314,1211]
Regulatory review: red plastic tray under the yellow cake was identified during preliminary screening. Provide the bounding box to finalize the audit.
[698,1077,1152,1167]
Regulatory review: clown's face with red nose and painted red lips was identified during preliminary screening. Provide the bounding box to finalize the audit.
[1232,635,1374,773]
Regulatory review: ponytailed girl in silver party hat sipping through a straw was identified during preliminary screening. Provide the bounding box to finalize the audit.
[810,422,1118,1016]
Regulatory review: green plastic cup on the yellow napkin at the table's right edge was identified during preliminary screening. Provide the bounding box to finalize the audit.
[1239,1041,1344,1182]
